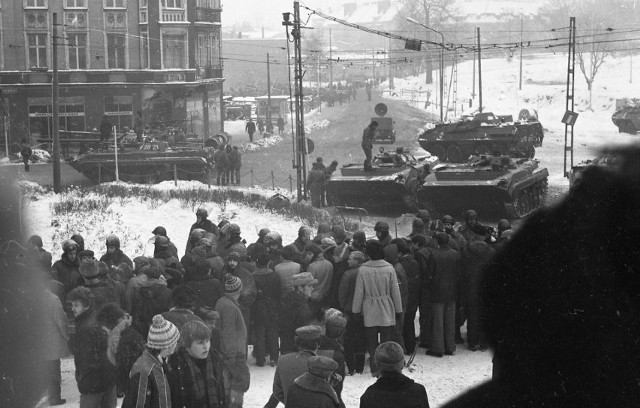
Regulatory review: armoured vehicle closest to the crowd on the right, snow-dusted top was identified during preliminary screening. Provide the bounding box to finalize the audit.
[417,155,549,219]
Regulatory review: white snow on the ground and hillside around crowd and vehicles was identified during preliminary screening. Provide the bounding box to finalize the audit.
[15,54,640,407]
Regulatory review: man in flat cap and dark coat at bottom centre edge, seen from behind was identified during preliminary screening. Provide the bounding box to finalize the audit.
[284,356,340,408]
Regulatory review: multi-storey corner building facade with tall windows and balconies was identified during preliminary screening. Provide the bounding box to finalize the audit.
[0,0,223,151]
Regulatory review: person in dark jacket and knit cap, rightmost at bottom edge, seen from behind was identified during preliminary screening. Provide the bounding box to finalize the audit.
[360,341,429,408]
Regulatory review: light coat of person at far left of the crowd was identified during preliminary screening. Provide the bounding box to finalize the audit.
[42,290,70,360]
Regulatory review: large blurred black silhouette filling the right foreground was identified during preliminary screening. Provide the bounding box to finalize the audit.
[444,145,640,408]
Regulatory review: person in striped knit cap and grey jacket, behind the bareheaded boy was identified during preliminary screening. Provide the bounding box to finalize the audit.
[216,274,250,408]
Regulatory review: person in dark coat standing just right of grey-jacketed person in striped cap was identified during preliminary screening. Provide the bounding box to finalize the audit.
[251,244,282,367]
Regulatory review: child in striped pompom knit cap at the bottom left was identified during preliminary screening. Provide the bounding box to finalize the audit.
[122,315,180,408]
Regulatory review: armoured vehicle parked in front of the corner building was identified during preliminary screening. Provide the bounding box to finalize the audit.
[69,141,212,184]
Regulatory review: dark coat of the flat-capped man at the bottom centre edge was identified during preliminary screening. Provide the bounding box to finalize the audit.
[285,373,340,408]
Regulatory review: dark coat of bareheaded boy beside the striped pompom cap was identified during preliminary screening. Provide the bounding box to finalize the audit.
[167,348,226,408]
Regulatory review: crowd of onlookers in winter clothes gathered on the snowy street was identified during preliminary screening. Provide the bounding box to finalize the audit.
[28,208,511,408]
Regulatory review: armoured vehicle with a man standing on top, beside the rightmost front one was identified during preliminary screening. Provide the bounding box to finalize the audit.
[326,147,438,209]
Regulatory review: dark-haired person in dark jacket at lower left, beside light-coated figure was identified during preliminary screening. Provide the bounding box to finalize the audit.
[67,287,117,408]
